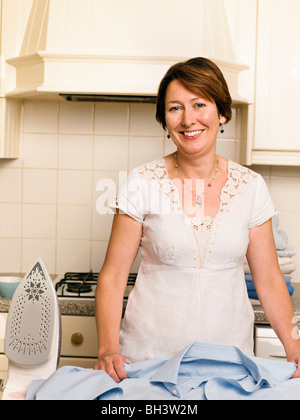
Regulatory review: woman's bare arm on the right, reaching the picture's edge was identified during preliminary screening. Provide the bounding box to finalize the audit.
[247,220,300,377]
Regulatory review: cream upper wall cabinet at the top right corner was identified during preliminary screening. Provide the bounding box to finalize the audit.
[252,0,300,165]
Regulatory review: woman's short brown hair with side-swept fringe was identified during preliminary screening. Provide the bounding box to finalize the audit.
[156,57,232,130]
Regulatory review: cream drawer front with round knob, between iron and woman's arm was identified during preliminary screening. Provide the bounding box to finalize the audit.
[61,316,98,358]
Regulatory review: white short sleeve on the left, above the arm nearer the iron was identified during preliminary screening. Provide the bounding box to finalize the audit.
[109,169,145,223]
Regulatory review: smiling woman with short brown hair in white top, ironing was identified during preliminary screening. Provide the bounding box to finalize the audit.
[95,58,300,382]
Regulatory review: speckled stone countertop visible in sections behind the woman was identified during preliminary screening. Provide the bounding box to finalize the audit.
[0,283,300,324]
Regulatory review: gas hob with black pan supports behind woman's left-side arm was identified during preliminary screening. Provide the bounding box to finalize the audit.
[54,271,137,301]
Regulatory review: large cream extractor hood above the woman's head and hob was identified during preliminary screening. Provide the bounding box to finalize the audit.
[6,0,248,103]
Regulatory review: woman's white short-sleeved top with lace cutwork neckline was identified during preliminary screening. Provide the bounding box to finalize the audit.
[111,158,276,362]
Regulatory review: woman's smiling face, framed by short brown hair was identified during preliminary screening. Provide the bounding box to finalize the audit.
[165,80,226,154]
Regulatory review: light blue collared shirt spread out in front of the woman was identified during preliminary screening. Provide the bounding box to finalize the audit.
[26,343,300,400]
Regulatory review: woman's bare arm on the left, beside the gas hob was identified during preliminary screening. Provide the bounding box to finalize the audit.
[95,214,142,382]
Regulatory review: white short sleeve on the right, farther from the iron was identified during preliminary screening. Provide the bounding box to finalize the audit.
[249,174,277,229]
